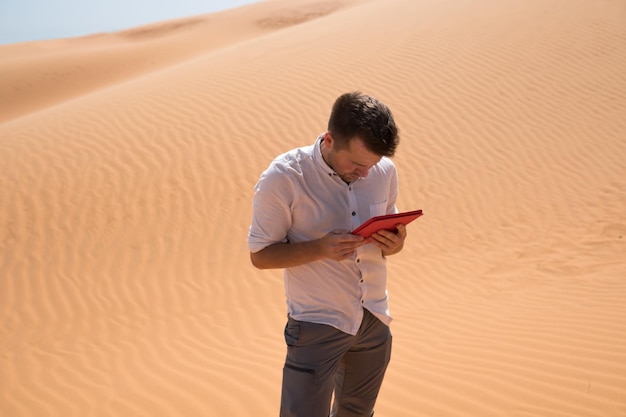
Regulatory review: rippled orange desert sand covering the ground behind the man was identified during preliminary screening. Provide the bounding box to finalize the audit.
[0,0,626,417]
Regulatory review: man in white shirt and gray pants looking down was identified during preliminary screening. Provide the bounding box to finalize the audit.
[248,92,406,417]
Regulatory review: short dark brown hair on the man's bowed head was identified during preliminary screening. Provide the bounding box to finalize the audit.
[328,91,399,156]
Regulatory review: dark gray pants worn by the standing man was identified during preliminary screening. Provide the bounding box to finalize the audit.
[280,310,391,417]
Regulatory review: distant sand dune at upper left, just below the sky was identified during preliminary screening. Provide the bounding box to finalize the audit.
[0,0,366,122]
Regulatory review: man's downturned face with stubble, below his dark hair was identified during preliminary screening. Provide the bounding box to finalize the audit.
[322,133,382,183]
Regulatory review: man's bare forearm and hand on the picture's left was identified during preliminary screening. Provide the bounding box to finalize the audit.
[250,233,367,269]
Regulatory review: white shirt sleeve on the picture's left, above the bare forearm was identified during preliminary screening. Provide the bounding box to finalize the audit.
[248,162,295,253]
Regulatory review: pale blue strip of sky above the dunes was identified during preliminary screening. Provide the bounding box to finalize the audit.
[0,0,259,44]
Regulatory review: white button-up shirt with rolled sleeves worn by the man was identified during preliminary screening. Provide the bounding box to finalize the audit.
[248,135,398,335]
